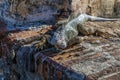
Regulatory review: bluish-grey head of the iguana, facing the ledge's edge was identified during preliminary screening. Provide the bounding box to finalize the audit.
[50,28,67,49]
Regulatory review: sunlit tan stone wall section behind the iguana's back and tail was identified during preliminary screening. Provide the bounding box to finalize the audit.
[72,0,120,17]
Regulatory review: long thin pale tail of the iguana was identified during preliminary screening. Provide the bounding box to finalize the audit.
[87,15,120,21]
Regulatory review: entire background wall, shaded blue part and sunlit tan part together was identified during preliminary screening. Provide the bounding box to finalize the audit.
[0,0,120,25]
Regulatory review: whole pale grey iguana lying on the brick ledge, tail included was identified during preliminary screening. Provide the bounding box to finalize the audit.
[50,14,120,49]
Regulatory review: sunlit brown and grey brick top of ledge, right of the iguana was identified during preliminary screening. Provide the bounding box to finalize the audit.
[52,22,120,80]
